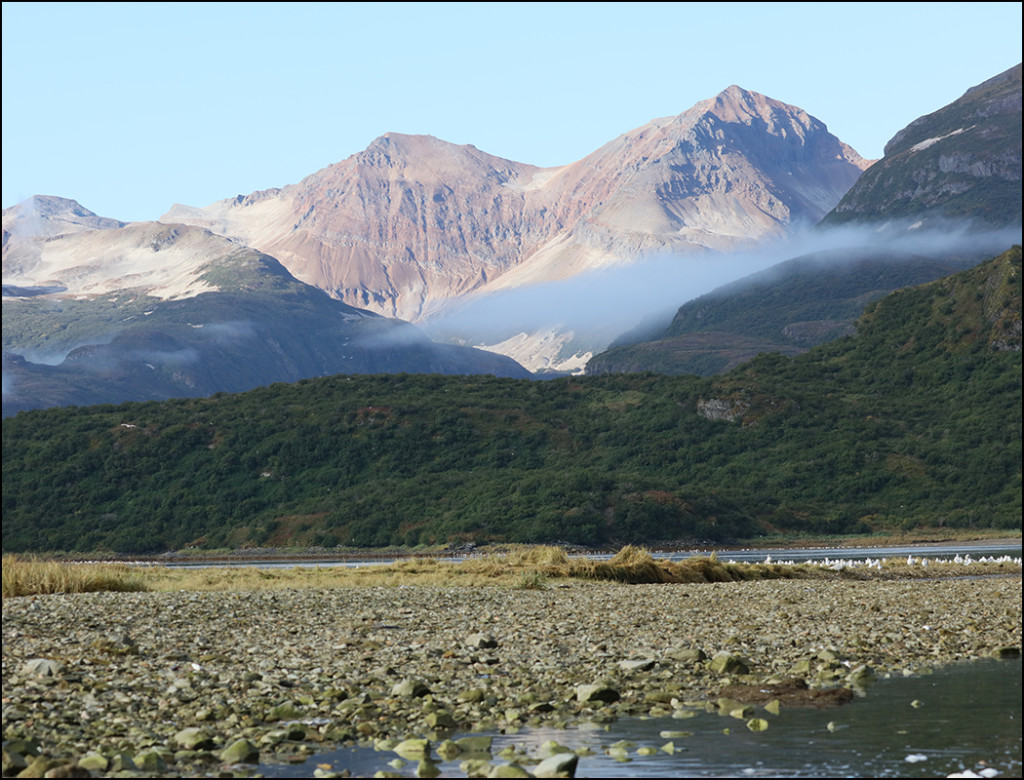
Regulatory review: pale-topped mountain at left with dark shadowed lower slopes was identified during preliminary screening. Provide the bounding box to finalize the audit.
[3,204,529,416]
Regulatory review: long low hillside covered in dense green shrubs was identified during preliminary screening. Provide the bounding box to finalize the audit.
[3,247,1021,553]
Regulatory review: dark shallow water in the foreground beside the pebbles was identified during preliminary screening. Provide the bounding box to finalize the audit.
[259,659,1022,778]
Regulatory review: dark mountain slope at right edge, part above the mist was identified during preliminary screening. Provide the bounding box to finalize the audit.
[822,64,1022,227]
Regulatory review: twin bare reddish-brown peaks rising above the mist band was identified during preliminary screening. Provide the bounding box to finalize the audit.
[163,87,868,320]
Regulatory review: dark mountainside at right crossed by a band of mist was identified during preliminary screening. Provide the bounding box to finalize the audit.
[587,66,1022,375]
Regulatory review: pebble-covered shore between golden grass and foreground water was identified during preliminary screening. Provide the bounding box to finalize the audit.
[3,577,1021,777]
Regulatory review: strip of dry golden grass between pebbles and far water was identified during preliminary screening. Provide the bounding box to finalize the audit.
[3,545,1021,598]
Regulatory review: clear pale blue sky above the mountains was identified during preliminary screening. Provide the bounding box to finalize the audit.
[2,2,1021,220]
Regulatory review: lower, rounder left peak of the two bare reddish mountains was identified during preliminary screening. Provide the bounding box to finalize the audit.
[163,133,547,320]
